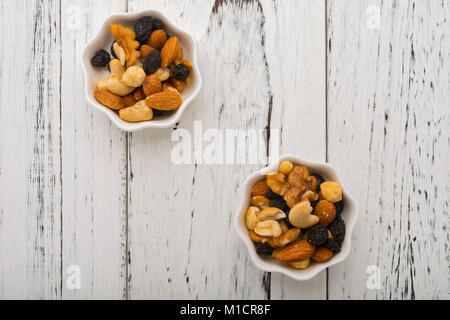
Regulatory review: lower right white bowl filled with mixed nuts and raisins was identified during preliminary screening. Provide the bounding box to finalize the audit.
[234,155,358,280]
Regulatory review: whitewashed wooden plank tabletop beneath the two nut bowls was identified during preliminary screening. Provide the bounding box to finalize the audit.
[0,0,450,299]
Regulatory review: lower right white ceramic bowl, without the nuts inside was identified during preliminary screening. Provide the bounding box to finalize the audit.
[234,155,358,280]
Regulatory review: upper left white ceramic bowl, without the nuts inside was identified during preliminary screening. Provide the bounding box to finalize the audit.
[81,9,202,132]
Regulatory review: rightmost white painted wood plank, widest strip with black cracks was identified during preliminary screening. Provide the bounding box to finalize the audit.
[328,0,450,299]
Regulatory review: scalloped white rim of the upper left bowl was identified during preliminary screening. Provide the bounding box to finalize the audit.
[80,9,203,132]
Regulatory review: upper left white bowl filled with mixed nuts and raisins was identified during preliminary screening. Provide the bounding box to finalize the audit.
[82,10,202,132]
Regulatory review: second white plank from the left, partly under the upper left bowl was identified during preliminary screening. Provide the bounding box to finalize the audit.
[61,0,126,299]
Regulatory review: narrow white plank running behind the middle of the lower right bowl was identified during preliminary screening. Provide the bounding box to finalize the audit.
[261,0,327,299]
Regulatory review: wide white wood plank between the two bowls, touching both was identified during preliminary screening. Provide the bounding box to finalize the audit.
[129,1,270,299]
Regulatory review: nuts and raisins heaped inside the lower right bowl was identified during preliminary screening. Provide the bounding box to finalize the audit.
[246,161,345,269]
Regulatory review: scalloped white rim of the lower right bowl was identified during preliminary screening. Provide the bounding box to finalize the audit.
[233,154,359,281]
